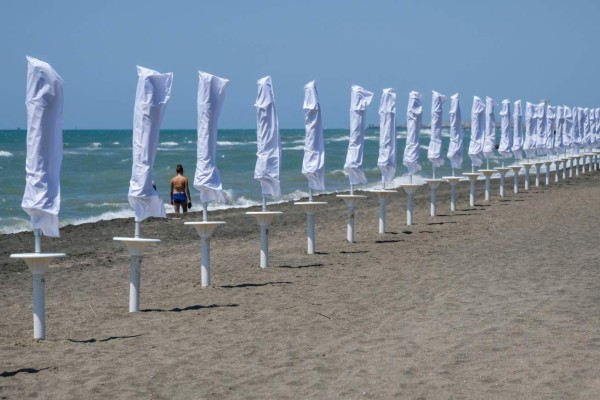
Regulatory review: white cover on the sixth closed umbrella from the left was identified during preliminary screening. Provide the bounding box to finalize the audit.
[344,85,373,185]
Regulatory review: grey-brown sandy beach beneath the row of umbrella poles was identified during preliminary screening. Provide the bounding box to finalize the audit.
[0,171,600,399]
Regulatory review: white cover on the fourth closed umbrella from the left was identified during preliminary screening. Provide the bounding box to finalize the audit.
[254,76,281,198]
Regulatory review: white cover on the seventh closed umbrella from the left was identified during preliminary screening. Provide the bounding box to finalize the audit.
[377,88,396,182]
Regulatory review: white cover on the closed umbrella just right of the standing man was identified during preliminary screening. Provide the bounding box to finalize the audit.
[194,71,229,203]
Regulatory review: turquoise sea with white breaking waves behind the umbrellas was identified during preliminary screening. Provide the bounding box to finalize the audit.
[0,127,500,234]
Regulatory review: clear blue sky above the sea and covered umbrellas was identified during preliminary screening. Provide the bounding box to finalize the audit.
[0,0,600,129]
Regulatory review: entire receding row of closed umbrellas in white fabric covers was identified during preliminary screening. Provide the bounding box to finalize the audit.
[22,57,600,236]
